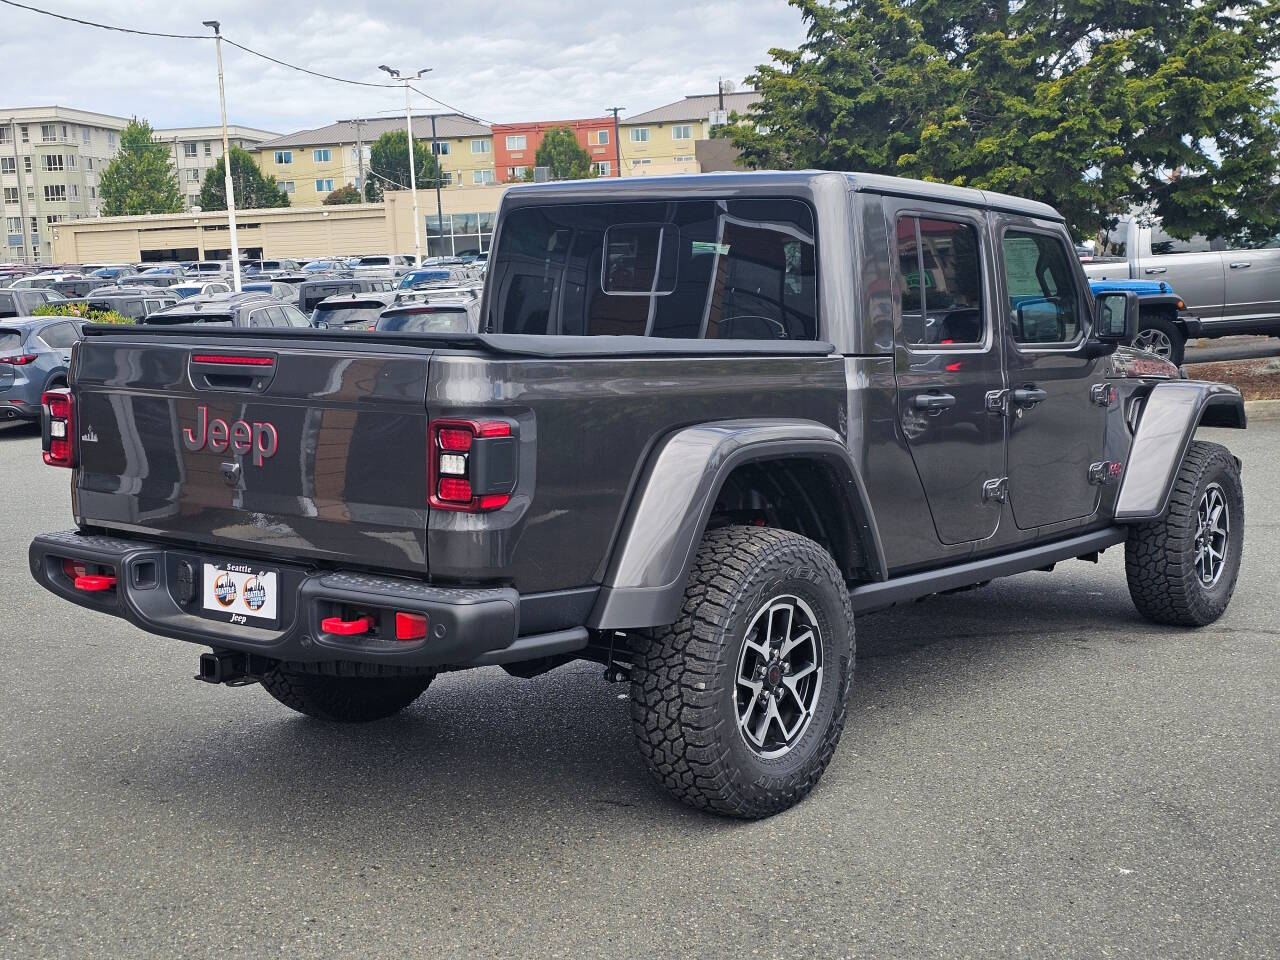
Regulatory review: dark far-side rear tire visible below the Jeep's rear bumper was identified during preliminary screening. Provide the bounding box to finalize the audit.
[262,668,431,723]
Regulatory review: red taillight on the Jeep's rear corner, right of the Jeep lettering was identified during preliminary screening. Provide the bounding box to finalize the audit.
[428,420,516,513]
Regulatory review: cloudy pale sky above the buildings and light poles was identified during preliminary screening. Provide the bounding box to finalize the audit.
[0,0,804,133]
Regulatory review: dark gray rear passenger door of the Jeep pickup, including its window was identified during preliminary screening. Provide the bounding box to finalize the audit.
[888,205,1005,544]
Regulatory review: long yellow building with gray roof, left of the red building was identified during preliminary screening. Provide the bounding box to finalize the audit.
[253,114,495,206]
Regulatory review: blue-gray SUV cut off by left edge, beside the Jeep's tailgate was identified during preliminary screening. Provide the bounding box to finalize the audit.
[0,316,81,422]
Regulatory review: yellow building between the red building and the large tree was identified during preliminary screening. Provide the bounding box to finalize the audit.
[618,90,760,177]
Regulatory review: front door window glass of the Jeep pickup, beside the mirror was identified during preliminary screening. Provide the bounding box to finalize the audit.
[1002,230,1083,343]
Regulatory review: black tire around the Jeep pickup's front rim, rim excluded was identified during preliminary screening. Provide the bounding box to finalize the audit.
[1124,440,1244,627]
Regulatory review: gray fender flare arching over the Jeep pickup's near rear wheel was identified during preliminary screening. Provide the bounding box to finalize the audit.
[588,419,887,630]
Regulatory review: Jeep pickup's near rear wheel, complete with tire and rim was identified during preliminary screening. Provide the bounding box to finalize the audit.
[631,527,854,818]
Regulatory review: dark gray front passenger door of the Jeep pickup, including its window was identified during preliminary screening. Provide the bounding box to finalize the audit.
[997,218,1106,530]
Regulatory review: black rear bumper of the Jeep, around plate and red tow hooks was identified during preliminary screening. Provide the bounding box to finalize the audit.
[29,530,588,667]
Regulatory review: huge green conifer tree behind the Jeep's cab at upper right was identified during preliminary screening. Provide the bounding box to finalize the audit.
[721,0,1280,242]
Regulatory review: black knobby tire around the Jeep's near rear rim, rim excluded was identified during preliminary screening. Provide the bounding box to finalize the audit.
[631,526,854,819]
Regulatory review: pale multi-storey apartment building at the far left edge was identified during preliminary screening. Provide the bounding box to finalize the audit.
[0,106,128,264]
